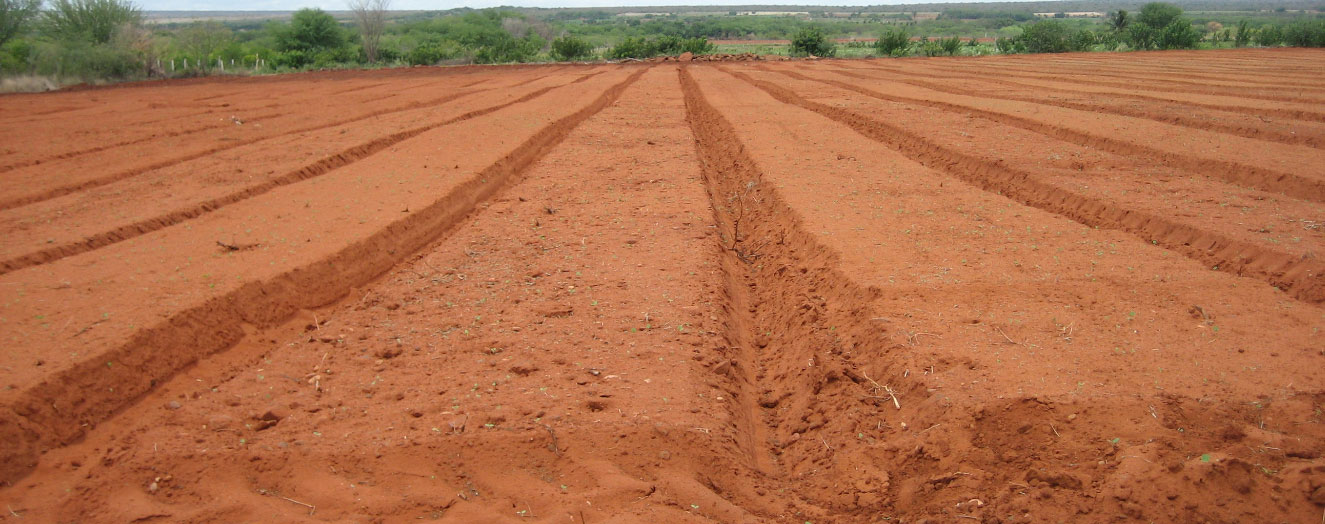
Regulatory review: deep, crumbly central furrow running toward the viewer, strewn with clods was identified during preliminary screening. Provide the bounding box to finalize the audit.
[680,68,924,512]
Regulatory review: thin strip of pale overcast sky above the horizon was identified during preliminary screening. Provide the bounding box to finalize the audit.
[145,0,1007,11]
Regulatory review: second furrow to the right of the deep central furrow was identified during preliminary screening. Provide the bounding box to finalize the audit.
[778,70,1325,202]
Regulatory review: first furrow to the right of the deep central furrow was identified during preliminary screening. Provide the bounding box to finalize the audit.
[719,68,1325,304]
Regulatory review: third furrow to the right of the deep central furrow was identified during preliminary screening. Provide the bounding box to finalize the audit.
[831,69,1325,149]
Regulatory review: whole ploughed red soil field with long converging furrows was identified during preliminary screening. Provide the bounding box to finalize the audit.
[0,49,1325,524]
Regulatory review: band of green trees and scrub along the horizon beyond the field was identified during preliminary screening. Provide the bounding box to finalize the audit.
[0,0,1325,89]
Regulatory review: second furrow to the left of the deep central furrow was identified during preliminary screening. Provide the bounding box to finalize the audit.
[0,86,557,275]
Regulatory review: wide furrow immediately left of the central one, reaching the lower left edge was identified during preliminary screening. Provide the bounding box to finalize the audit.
[0,68,647,482]
